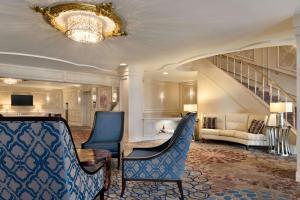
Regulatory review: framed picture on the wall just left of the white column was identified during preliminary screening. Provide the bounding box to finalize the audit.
[98,86,112,111]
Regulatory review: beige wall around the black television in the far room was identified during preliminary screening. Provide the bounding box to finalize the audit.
[0,86,64,115]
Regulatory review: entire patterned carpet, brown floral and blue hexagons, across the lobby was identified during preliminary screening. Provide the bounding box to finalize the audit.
[72,128,300,200]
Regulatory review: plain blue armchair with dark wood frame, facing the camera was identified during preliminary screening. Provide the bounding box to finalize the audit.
[82,111,124,169]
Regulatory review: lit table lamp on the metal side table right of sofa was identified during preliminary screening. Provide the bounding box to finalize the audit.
[270,102,293,127]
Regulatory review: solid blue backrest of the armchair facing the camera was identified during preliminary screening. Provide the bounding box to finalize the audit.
[89,111,124,142]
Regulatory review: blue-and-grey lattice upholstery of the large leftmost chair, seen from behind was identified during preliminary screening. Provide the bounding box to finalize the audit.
[0,121,104,200]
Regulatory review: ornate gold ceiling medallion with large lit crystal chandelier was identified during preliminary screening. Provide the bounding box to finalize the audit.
[34,2,126,43]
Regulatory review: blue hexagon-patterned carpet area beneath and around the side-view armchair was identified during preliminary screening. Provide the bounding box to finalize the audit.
[105,167,210,200]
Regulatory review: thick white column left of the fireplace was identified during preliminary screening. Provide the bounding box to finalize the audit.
[120,67,144,142]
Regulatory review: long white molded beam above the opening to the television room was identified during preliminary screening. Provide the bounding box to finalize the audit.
[0,63,120,86]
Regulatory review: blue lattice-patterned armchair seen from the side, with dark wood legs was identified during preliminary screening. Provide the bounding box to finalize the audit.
[121,113,196,199]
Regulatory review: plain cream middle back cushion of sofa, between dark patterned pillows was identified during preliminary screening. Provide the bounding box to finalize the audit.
[226,113,249,131]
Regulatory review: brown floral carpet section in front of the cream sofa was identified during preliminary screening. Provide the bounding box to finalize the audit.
[187,142,300,200]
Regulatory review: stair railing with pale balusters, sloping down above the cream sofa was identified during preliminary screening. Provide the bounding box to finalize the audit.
[209,54,297,128]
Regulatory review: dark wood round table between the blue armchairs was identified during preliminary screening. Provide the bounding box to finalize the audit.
[76,149,111,190]
